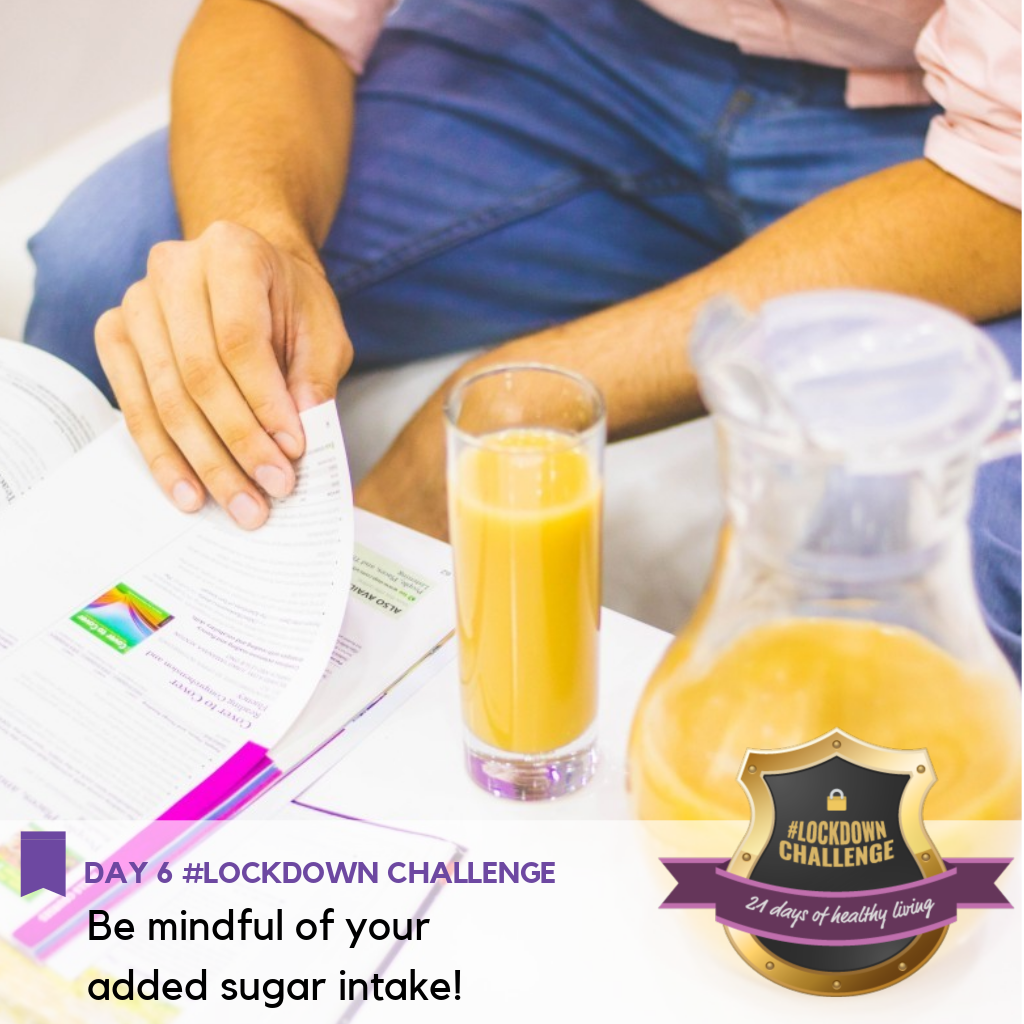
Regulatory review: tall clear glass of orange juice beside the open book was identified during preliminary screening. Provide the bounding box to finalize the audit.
[446,365,604,800]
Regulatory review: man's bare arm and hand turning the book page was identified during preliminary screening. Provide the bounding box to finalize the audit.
[96,0,354,527]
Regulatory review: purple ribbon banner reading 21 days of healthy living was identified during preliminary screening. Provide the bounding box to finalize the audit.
[662,857,1013,946]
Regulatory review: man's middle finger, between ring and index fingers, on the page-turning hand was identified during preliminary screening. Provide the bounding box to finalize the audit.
[151,243,295,498]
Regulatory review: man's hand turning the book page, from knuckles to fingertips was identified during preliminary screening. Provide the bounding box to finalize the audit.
[96,221,352,529]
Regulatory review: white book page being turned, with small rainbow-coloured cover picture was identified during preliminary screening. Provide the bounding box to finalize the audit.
[0,402,352,821]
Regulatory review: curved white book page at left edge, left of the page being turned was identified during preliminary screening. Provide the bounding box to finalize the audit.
[0,339,120,512]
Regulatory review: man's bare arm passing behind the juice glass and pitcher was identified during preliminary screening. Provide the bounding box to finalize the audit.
[356,160,1021,537]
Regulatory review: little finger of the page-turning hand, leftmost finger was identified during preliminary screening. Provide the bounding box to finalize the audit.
[96,309,206,512]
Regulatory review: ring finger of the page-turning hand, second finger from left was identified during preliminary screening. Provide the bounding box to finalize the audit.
[122,282,269,529]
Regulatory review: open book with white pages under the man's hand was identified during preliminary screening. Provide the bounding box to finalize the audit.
[0,341,454,888]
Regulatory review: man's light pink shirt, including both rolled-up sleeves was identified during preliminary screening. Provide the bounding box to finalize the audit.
[271,0,1021,209]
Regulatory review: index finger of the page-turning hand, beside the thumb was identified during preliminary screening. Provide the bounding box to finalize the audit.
[205,232,305,459]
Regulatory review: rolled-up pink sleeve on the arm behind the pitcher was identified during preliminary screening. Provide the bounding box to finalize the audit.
[916,0,1021,210]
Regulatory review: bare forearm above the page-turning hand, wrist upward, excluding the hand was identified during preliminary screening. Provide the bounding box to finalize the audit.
[171,0,354,258]
